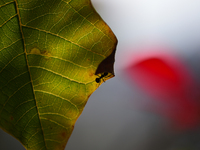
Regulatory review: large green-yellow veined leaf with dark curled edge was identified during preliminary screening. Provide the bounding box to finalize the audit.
[0,0,117,150]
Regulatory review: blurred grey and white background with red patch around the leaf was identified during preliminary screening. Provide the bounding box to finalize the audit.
[0,0,200,150]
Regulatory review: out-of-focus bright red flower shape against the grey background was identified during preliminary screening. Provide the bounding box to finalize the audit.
[126,48,200,129]
